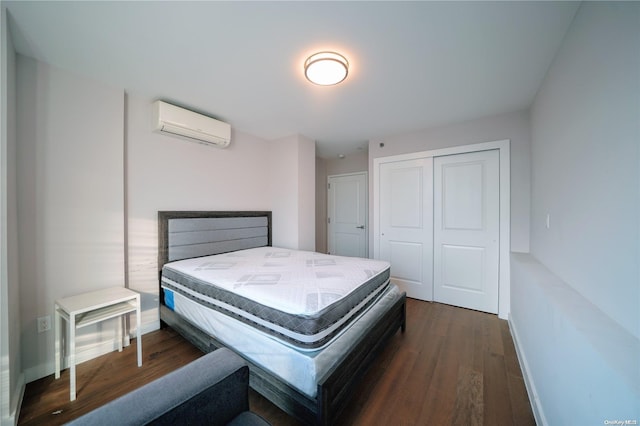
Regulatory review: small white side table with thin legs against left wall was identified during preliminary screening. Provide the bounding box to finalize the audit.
[54,287,142,401]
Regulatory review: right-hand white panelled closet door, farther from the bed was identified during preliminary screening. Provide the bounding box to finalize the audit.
[433,150,500,313]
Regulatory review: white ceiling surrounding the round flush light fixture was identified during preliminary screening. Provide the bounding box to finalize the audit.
[3,1,579,157]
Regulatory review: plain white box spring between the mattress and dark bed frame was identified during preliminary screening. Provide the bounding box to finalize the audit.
[165,285,402,398]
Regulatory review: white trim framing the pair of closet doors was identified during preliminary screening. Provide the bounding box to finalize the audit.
[369,139,511,319]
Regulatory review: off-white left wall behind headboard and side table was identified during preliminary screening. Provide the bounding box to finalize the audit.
[10,73,315,382]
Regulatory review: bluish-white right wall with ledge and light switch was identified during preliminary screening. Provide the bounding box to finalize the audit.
[511,2,640,425]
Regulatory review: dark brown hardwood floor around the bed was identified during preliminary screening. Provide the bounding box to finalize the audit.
[18,299,535,426]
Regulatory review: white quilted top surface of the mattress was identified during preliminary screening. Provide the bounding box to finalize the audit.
[166,247,389,316]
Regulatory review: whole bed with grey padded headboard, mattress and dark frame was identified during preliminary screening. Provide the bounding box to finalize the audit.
[158,211,406,425]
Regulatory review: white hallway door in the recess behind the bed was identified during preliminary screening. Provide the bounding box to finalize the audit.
[327,173,369,257]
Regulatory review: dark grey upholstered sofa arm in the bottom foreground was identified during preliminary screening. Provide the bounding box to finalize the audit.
[69,349,268,426]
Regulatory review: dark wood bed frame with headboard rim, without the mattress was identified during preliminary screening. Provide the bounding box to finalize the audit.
[158,211,406,425]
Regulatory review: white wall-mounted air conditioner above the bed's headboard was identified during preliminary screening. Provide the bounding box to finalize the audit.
[153,101,231,148]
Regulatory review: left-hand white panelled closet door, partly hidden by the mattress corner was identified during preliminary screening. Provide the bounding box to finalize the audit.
[379,158,433,300]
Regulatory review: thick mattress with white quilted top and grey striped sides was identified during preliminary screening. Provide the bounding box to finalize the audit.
[162,247,390,350]
